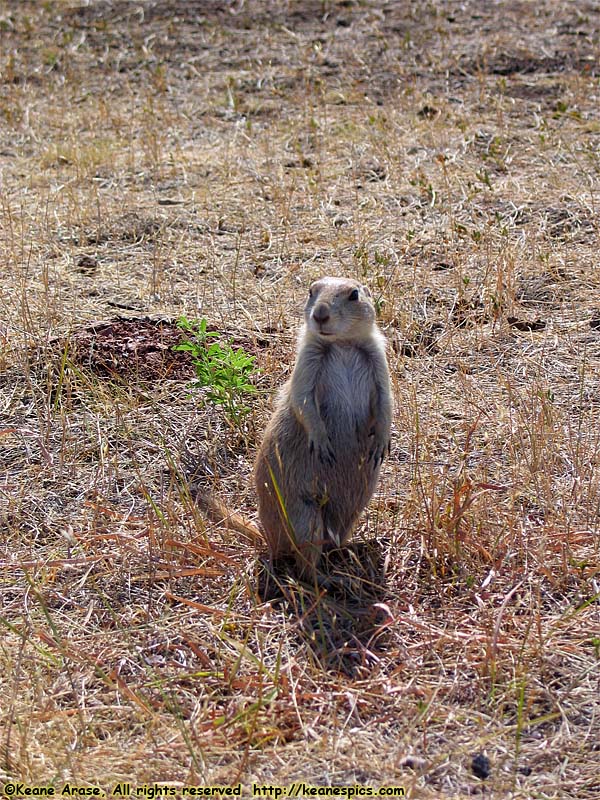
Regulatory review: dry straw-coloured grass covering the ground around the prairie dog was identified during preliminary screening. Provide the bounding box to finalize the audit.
[0,0,600,800]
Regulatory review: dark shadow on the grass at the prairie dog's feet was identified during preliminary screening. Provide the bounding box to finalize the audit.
[257,539,389,676]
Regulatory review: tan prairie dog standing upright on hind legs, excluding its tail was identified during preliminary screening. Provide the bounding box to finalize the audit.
[254,278,392,572]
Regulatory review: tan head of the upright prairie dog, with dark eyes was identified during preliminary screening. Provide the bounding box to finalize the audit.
[304,278,375,342]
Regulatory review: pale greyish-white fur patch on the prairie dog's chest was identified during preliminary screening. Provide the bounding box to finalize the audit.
[315,344,375,420]
